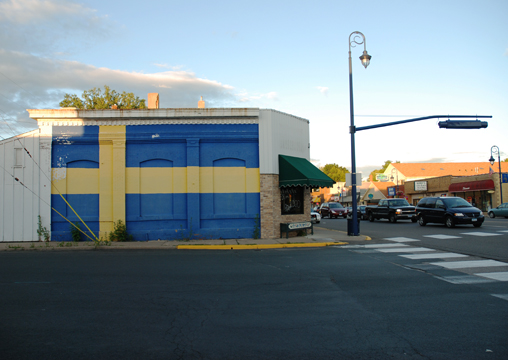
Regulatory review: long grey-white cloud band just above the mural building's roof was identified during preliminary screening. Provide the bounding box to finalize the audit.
[0,49,239,137]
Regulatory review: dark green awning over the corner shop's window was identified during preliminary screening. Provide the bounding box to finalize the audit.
[279,155,335,188]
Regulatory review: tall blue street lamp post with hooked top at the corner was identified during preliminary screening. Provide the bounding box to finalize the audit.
[349,31,371,236]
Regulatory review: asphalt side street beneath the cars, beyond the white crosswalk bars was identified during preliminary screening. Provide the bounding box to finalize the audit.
[316,217,508,262]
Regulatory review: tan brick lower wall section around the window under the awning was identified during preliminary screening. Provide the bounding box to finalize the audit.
[260,174,311,239]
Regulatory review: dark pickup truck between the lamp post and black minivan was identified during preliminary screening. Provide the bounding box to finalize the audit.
[366,199,418,223]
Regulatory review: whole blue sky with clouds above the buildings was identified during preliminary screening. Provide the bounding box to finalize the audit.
[0,0,508,177]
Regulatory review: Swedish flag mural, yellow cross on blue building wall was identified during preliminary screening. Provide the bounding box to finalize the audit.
[51,123,260,240]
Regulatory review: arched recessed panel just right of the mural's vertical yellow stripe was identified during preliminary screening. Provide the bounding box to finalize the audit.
[139,159,174,218]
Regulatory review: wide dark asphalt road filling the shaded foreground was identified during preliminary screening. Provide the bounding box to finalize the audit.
[0,245,508,360]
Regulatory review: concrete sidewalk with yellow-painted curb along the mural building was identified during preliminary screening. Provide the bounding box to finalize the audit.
[0,226,370,251]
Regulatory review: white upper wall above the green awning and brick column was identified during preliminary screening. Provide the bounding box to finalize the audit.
[259,109,310,174]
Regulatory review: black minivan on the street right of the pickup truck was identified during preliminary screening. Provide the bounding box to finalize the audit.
[416,197,485,228]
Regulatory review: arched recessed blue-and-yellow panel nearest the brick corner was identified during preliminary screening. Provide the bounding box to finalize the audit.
[213,158,247,215]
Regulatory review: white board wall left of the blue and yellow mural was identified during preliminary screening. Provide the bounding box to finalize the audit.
[0,129,51,242]
